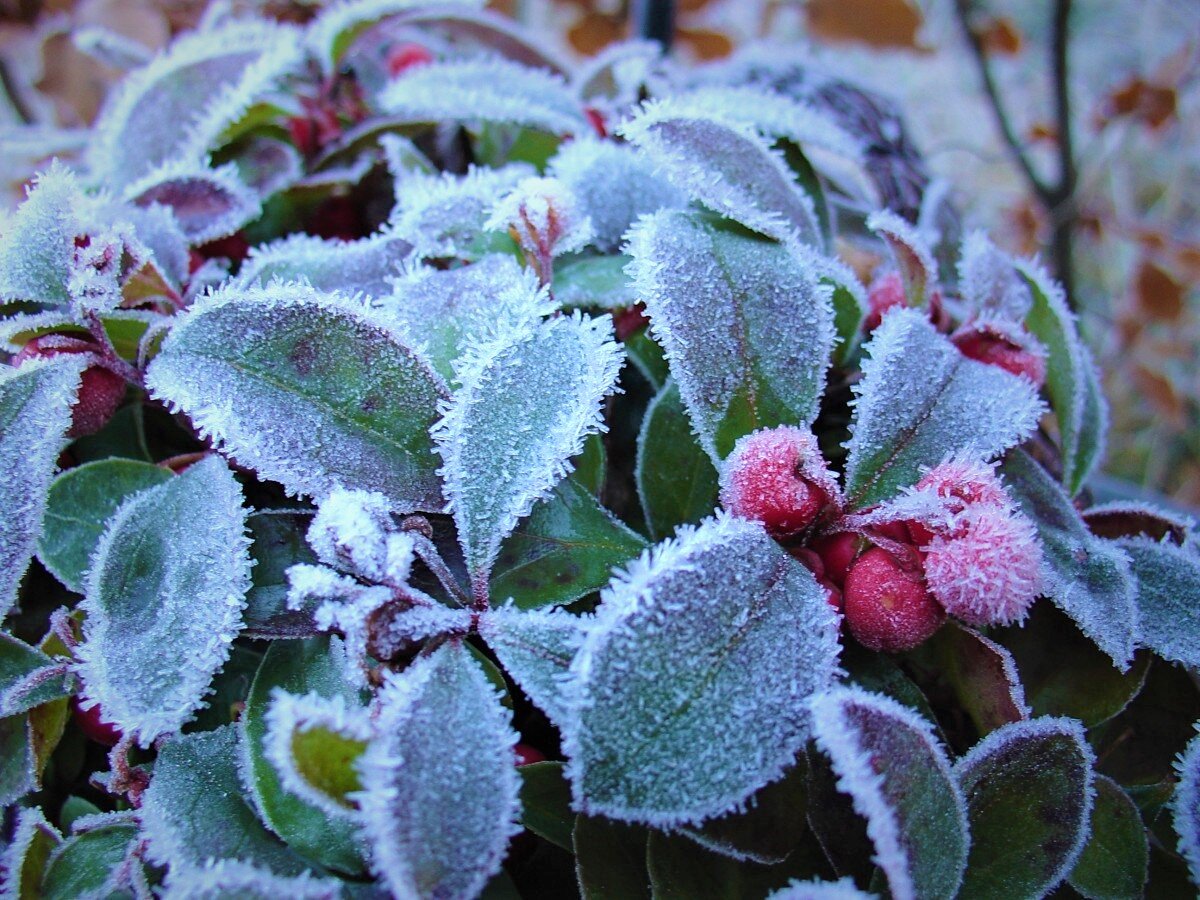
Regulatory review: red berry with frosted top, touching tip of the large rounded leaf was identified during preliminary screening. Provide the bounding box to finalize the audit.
[721,425,839,536]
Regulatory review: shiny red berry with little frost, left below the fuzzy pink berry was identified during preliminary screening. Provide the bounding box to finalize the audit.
[842,547,946,653]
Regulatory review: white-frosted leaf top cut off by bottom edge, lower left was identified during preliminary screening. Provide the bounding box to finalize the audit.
[158,859,343,900]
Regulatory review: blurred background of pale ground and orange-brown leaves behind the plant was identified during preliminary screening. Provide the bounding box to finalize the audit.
[0,0,1200,508]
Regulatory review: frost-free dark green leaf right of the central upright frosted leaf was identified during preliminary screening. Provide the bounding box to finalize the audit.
[490,476,646,610]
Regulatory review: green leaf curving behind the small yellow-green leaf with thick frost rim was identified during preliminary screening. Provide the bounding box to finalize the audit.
[238,637,362,875]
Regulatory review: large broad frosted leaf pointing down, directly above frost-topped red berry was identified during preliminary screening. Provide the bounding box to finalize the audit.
[629,210,834,461]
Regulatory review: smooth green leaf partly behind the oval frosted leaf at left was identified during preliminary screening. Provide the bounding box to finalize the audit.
[37,460,172,593]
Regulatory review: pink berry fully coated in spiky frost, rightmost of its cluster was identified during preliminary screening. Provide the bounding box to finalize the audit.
[924,504,1042,625]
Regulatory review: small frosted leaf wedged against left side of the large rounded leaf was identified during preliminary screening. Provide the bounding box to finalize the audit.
[479,604,583,727]
